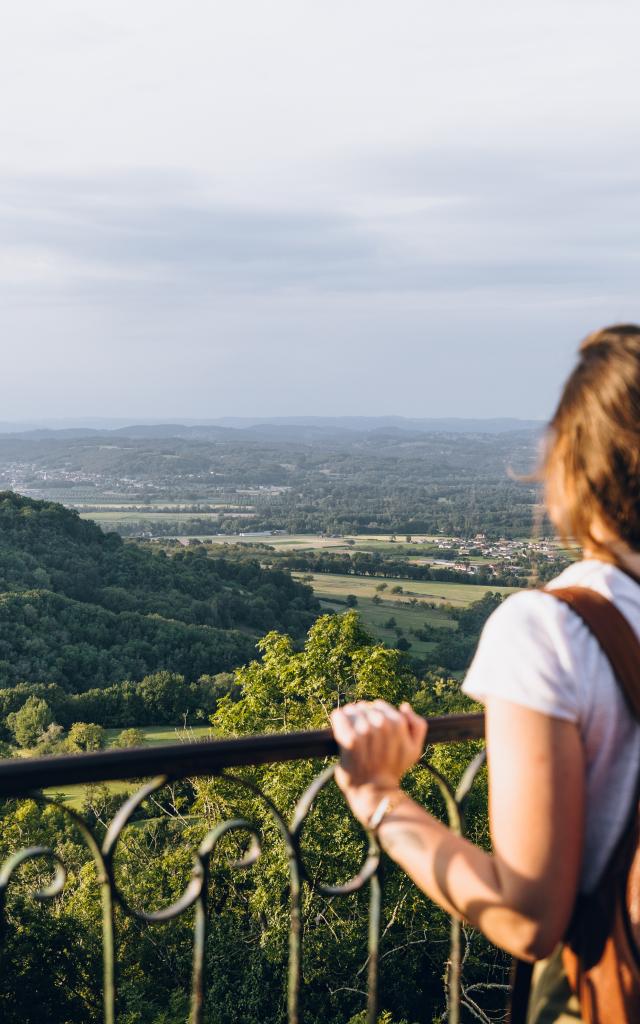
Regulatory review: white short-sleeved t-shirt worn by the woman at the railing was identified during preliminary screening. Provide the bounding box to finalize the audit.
[462,559,640,892]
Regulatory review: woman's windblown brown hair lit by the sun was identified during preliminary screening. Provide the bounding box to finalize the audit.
[541,324,640,550]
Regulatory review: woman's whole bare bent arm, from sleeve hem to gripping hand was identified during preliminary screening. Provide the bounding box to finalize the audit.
[332,697,585,959]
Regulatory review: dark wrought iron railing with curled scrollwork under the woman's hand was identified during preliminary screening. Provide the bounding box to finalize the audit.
[0,715,484,1024]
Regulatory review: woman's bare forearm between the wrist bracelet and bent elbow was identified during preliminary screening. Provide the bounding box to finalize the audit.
[377,792,560,959]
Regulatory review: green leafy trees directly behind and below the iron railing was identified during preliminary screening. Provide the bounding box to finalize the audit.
[0,611,502,1024]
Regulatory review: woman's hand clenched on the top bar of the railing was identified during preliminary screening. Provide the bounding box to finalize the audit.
[331,700,427,825]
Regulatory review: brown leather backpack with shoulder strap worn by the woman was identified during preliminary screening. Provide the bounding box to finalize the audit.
[509,587,640,1024]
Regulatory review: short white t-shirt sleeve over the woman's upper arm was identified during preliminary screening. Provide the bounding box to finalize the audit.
[462,591,584,722]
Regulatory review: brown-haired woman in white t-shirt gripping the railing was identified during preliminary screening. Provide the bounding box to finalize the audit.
[332,325,640,1020]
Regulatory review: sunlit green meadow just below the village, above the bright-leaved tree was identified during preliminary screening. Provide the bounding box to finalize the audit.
[294,572,515,657]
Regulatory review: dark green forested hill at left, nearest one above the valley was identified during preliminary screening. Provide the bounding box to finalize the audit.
[0,492,318,691]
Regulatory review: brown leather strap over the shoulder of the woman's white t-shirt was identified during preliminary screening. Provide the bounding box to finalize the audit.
[545,587,640,722]
